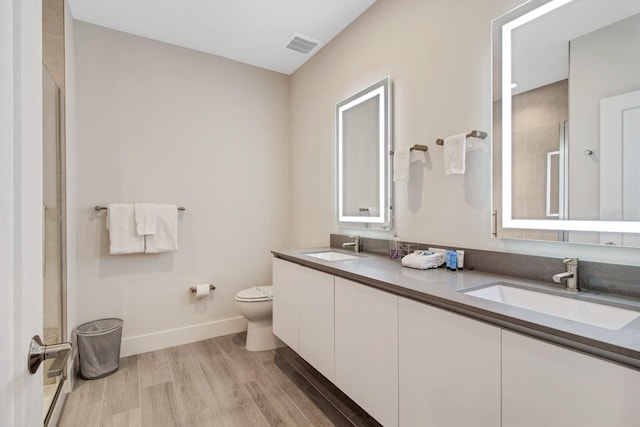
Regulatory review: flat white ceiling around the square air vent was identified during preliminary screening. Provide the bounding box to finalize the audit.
[69,0,375,74]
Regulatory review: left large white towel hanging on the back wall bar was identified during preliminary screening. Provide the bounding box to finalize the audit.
[107,203,144,255]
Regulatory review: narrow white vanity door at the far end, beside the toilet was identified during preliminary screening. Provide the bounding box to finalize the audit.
[272,258,301,353]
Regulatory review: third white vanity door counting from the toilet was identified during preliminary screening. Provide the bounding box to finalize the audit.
[335,277,398,427]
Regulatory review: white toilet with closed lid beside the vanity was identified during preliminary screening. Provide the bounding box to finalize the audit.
[236,286,284,351]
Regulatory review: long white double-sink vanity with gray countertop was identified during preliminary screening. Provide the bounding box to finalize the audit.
[273,248,640,427]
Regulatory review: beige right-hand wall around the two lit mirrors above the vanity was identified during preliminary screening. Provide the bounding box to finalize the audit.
[291,0,640,265]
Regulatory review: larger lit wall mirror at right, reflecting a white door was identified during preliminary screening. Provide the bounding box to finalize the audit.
[492,0,640,246]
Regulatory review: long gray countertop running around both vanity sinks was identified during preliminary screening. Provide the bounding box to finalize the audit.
[272,247,640,369]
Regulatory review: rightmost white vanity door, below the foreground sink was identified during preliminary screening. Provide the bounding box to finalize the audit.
[502,330,640,427]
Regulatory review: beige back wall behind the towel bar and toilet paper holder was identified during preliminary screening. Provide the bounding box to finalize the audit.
[74,22,291,355]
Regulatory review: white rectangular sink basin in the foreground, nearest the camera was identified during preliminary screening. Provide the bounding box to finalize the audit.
[464,284,640,330]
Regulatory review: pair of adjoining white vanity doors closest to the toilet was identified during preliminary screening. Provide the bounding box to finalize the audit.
[273,258,334,381]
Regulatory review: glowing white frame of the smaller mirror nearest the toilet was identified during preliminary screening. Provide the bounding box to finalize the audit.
[336,77,392,229]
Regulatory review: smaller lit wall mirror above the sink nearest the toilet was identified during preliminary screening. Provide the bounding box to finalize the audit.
[336,77,392,230]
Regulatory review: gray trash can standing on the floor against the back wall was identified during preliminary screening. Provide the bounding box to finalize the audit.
[76,318,124,380]
